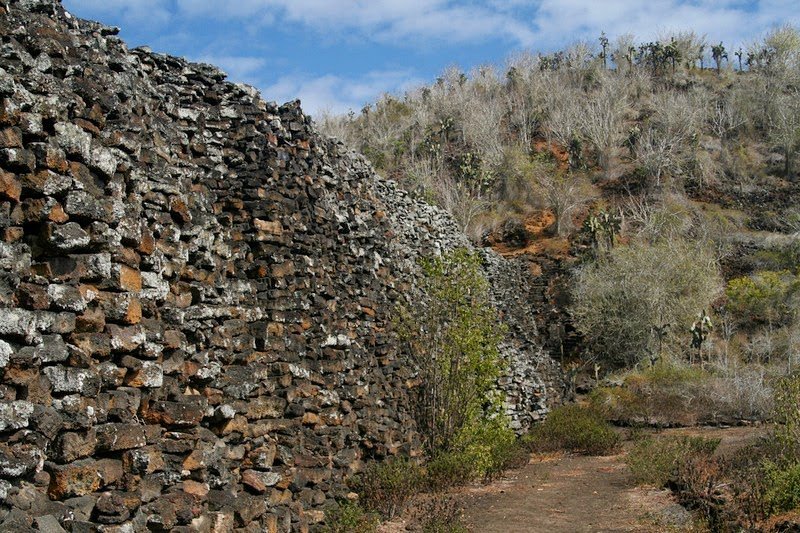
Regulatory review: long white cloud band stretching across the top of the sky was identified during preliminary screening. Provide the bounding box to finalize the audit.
[64,0,800,52]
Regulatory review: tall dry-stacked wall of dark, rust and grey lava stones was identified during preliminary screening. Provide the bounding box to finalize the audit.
[0,0,556,532]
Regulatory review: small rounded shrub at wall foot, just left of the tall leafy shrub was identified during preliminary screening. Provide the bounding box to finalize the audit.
[353,457,424,519]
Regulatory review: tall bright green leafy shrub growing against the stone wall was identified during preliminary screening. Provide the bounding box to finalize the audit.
[398,248,505,455]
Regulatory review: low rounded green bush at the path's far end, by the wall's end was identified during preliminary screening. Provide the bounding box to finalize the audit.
[525,404,620,455]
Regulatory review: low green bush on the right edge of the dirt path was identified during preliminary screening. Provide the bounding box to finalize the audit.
[625,437,720,487]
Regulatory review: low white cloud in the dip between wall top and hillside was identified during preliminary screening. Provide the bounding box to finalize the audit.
[261,70,421,115]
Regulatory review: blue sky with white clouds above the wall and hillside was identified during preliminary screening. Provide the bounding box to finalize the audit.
[63,0,800,114]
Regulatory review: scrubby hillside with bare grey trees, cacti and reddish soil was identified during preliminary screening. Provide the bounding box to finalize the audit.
[321,26,800,371]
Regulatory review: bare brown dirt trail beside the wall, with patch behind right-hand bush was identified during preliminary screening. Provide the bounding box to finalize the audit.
[463,428,760,533]
